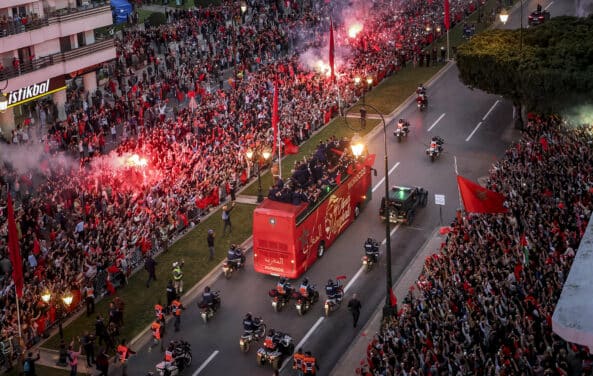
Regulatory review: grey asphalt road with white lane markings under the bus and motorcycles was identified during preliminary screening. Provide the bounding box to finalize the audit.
[128,1,574,376]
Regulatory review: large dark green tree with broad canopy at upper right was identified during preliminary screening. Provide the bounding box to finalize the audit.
[457,16,593,128]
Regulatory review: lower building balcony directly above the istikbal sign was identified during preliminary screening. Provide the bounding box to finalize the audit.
[0,38,115,87]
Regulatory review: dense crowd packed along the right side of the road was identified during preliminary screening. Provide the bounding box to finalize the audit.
[359,117,593,376]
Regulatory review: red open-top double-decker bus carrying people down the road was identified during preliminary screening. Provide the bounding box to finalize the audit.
[253,155,375,279]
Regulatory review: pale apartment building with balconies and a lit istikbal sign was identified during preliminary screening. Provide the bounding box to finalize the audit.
[0,0,115,138]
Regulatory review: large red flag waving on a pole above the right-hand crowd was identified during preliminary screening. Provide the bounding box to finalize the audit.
[457,175,507,213]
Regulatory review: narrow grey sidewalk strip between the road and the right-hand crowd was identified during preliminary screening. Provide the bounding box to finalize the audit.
[330,227,445,376]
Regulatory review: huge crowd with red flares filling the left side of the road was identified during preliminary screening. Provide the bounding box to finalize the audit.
[0,0,486,352]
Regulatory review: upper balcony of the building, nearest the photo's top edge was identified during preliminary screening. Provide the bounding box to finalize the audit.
[0,0,113,43]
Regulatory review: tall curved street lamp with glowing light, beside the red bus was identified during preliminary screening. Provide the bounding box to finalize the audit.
[345,104,395,318]
